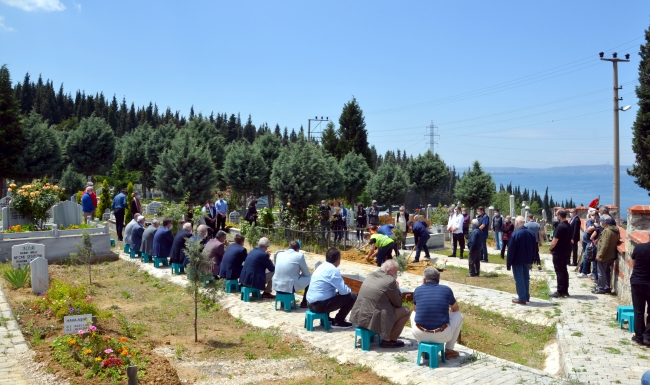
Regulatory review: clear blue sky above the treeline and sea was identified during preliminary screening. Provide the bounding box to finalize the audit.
[0,0,650,168]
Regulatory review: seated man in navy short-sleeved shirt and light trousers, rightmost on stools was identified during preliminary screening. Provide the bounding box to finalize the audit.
[411,267,463,359]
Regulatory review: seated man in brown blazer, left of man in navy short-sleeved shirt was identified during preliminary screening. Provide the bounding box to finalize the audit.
[350,259,411,348]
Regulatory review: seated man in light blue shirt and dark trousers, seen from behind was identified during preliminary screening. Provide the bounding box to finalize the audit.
[306,247,357,328]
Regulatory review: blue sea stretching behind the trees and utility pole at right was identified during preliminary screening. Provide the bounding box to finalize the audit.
[484,165,650,217]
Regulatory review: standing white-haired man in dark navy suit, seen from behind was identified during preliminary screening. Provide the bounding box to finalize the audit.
[506,216,537,305]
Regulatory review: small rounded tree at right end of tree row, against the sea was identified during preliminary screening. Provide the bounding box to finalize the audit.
[454,160,495,209]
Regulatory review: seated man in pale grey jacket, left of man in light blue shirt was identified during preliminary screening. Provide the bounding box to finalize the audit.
[273,241,311,308]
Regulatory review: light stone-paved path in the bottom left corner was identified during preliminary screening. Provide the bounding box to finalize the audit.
[0,288,29,385]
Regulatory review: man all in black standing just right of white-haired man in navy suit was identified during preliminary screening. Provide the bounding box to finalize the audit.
[549,209,572,298]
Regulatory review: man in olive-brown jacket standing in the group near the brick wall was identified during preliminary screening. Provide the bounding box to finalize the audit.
[591,214,621,294]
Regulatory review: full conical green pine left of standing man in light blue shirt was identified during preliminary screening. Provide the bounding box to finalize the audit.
[154,130,217,203]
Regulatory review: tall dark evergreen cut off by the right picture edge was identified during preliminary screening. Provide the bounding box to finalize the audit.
[627,28,650,195]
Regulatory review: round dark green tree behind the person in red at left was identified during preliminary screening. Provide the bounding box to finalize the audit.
[65,114,115,176]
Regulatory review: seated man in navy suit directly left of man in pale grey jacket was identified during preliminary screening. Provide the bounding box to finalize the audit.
[240,238,275,299]
